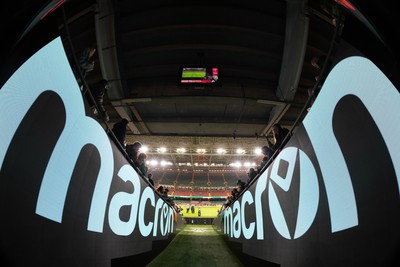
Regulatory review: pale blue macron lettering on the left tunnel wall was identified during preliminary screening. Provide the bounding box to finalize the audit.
[0,38,173,236]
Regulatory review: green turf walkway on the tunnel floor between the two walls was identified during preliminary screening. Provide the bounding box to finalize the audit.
[147,225,244,267]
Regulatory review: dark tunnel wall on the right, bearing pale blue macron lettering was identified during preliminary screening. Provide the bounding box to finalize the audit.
[216,56,400,266]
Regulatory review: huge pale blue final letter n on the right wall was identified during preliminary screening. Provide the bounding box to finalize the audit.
[303,57,400,232]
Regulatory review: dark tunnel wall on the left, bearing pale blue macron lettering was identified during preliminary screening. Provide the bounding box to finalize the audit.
[0,38,180,266]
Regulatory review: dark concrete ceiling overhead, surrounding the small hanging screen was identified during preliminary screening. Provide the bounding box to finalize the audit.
[61,0,334,141]
